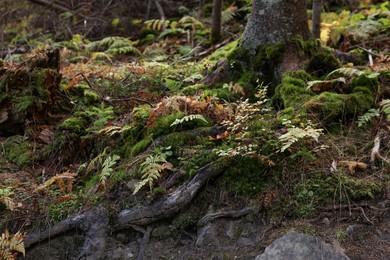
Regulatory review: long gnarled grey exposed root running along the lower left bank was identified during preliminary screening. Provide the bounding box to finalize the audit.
[25,146,230,259]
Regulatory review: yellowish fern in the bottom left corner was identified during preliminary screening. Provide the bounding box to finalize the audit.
[0,230,25,260]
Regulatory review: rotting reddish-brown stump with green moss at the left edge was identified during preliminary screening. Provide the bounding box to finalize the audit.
[0,48,61,136]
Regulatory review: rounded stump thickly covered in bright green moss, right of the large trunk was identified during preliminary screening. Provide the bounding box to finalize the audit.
[273,67,380,124]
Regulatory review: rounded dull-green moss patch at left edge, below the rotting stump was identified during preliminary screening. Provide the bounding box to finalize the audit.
[3,135,32,167]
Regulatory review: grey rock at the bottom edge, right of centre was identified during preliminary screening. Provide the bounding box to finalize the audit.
[256,231,349,260]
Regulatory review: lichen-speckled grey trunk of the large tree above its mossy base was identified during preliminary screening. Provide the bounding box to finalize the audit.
[240,0,310,53]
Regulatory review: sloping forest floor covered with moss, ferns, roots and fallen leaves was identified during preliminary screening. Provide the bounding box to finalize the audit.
[0,1,390,259]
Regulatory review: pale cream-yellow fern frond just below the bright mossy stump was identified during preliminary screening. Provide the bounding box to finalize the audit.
[279,124,323,152]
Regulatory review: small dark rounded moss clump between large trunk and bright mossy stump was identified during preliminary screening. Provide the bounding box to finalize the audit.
[306,50,341,77]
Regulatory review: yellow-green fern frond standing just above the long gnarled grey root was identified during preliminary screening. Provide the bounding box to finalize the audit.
[133,155,171,194]
